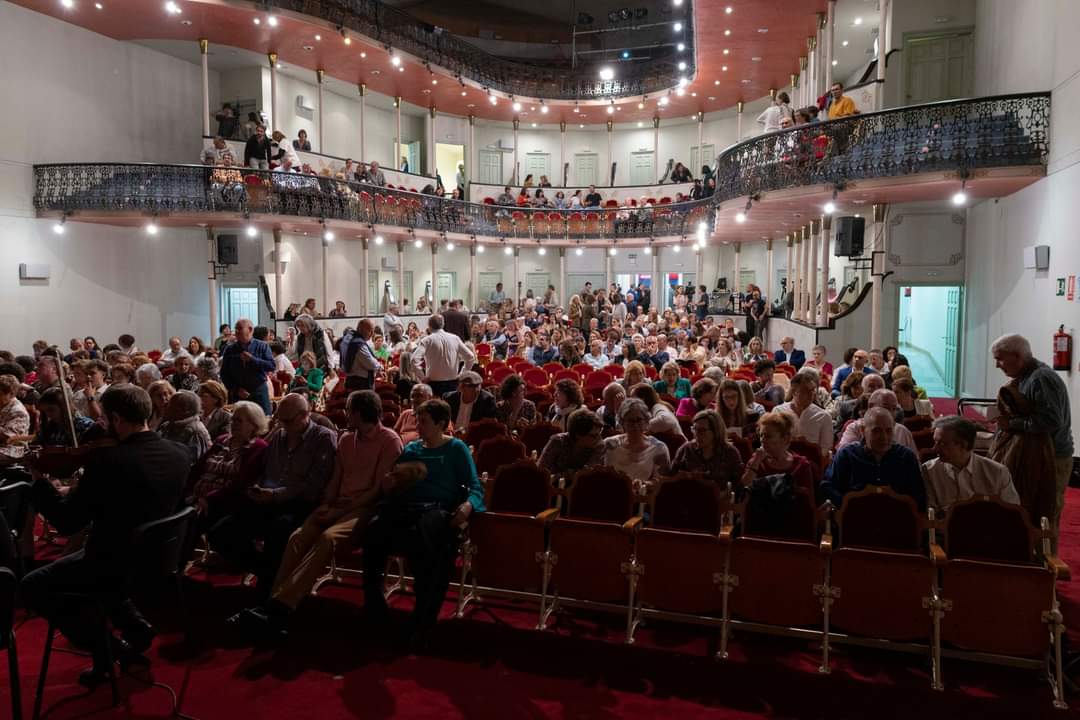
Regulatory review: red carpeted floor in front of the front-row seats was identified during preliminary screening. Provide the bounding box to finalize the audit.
[6,489,1080,720]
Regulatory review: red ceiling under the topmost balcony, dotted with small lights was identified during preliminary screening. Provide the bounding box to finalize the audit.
[12,0,826,124]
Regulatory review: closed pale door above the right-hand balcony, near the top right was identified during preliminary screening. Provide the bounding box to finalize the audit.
[904,32,975,105]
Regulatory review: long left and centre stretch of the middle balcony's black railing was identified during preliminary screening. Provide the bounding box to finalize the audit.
[35,163,713,241]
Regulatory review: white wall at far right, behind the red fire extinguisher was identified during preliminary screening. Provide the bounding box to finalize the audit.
[961,0,1080,437]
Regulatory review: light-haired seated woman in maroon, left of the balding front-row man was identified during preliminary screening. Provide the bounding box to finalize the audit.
[186,400,270,535]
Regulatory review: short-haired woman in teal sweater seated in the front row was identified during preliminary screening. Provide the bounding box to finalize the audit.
[363,399,485,647]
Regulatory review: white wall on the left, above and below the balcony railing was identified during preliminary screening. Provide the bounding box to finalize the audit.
[0,3,218,353]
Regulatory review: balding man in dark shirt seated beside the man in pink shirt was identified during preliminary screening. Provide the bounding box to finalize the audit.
[208,394,337,595]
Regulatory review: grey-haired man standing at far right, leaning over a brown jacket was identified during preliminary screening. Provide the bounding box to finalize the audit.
[990,335,1072,551]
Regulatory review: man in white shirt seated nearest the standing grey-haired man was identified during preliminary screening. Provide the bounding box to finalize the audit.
[922,416,1020,516]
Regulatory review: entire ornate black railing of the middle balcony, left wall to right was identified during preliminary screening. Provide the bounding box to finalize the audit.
[35,93,1050,242]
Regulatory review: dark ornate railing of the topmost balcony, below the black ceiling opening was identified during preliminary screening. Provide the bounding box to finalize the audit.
[264,0,694,100]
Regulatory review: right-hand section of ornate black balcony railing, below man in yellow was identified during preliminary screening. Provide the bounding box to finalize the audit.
[714,93,1050,202]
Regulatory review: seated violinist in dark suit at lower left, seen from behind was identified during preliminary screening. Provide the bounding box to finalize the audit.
[22,384,190,685]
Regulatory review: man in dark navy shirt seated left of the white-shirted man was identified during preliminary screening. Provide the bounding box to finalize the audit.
[821,407,927,511]
